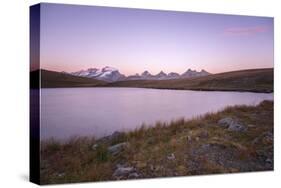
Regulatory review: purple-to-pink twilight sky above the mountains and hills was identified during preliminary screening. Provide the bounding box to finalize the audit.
[40,3,274,75]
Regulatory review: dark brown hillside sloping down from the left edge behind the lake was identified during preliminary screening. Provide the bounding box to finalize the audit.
[31,70,106,88]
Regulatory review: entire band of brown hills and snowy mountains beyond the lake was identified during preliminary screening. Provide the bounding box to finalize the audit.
[34,67,273,93]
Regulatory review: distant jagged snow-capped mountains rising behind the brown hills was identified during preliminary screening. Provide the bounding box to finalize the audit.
[68,66,211,82]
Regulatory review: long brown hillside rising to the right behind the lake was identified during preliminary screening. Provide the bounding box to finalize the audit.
[107,68,273,92]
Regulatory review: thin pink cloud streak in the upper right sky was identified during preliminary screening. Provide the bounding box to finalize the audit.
[224,26,268,36]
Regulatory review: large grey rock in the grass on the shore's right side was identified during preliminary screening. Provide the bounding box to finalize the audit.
[218,117,247,132]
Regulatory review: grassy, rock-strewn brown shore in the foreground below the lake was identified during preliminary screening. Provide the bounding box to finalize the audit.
[40,101,273,184]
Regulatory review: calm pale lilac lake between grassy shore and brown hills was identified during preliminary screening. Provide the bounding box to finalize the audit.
[40,88,273,139]
